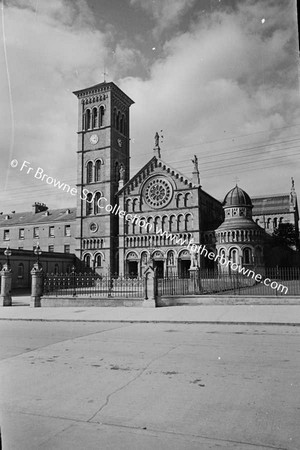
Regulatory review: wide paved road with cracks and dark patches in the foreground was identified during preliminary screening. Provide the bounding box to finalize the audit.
[0,321,300,450]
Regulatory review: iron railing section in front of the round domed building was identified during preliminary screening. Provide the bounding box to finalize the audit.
[157,267,300,297]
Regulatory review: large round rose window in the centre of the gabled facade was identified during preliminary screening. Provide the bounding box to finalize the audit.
[143,176,173,208]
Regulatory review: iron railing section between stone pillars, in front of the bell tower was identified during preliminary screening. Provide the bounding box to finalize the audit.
[43,272,144,298]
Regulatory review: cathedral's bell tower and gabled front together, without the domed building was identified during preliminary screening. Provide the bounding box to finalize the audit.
[75,83,223,276]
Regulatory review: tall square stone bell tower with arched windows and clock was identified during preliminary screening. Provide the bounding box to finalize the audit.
[74,82,134,273]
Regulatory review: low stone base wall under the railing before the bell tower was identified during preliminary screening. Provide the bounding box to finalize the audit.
[41,295,144,307]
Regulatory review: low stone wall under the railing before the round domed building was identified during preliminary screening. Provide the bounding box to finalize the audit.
[156,295,300,307]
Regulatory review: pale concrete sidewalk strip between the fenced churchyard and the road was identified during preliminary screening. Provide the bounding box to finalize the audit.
[0,297,300,326]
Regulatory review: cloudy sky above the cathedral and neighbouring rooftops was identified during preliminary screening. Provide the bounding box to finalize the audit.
[0,0,300,211]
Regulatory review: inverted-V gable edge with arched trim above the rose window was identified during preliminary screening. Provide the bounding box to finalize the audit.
[118,156,196,195]
